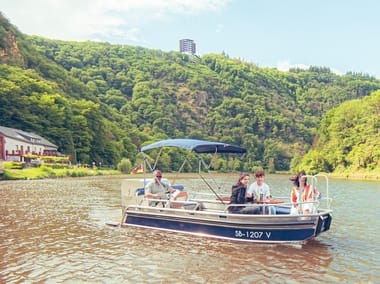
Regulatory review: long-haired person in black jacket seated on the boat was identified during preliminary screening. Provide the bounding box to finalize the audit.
[228,173,258,214]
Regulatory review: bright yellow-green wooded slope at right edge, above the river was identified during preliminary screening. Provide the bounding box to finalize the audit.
[301,91,380,175]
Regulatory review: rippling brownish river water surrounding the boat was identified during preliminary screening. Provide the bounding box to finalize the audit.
[0,175,380,283]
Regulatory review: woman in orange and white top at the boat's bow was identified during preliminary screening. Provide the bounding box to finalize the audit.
[290,171,321,214]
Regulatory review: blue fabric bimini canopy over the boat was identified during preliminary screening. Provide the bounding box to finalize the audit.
[141,139,246,154]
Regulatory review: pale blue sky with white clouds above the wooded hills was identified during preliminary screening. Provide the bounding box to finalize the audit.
[0,0,380,79]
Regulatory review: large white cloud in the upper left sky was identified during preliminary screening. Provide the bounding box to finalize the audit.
[0,0,231,42]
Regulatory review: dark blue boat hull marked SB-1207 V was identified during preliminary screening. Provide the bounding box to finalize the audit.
[123,212,331,243]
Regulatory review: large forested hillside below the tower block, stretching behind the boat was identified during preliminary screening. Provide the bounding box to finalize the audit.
[0,12,380,171]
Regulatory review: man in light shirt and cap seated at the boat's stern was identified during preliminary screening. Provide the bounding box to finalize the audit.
[145,170,188,206]
